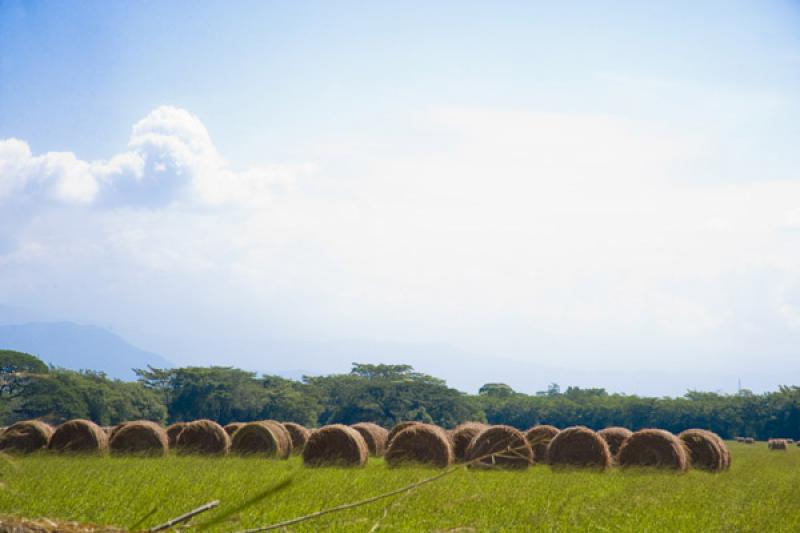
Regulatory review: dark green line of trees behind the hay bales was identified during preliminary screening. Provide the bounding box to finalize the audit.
[0,351,800,439]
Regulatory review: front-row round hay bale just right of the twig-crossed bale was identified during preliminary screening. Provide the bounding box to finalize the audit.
[547,426,611,470]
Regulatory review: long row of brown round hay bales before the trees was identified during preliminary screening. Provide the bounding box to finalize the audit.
[0,420,730,472]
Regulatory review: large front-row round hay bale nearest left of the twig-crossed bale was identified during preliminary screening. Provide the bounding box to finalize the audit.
[384,424,454,468]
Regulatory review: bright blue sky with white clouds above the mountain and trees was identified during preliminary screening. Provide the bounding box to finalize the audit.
[0,0,800,394]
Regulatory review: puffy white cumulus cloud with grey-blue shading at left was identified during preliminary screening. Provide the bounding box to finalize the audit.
[0,106,314,206]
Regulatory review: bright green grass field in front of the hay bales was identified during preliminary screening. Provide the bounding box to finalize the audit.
[0,443,800,532]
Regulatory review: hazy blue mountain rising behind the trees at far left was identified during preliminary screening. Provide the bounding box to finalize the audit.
[0,322,173,380]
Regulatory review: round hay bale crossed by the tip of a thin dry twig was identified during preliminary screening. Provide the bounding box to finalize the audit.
[466,426,534,469]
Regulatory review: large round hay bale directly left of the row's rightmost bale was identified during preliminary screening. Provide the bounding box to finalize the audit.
[617,429,689,472]
